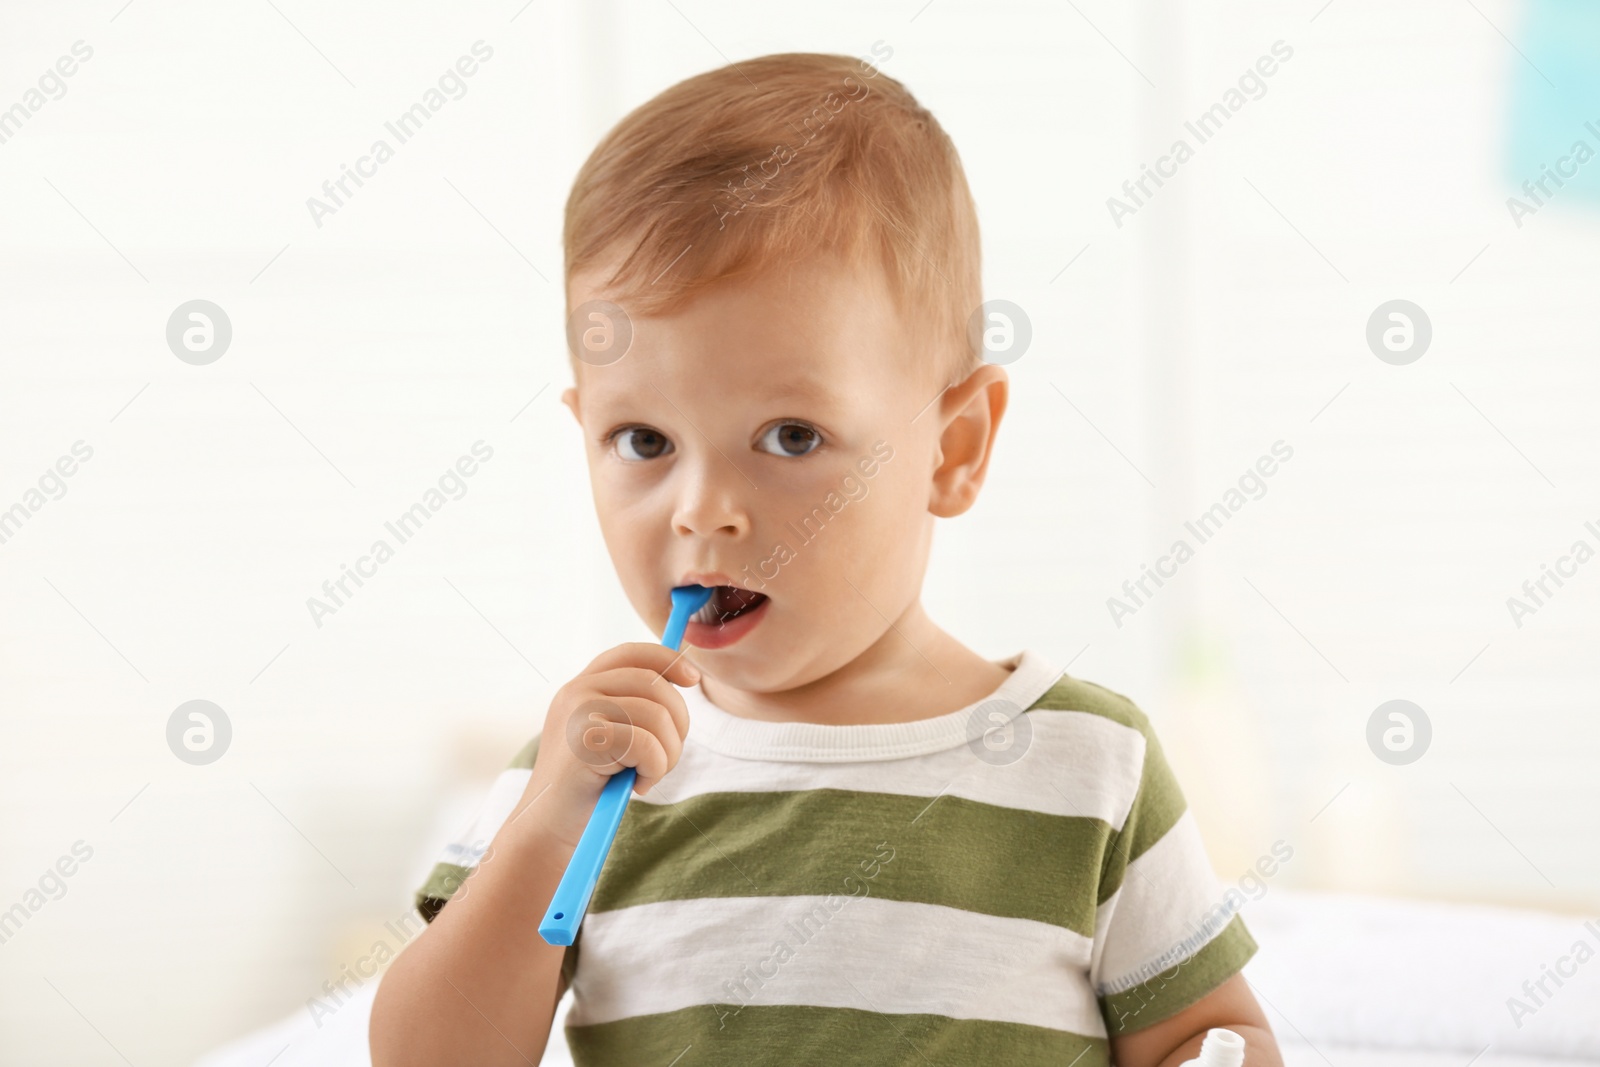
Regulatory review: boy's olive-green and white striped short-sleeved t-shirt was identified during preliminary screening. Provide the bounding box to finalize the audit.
[416,651,1256,1067]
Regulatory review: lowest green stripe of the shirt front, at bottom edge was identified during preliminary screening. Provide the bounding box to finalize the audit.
[566,990,1110,1067]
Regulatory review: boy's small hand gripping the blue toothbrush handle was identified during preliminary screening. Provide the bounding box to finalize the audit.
[525,641,701,848]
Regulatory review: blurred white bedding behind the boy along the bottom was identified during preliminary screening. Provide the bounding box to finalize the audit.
[195,888,1600,1067]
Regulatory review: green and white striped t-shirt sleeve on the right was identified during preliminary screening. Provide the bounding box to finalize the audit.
[1090,701,1258,1035]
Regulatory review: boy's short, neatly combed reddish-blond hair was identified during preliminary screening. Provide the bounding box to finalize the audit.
[562,53,982,382]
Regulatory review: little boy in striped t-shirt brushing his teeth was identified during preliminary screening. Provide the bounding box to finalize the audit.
[371,54,1282,1067]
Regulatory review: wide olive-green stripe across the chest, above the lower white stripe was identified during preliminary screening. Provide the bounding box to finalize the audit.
[589,789,1110,937]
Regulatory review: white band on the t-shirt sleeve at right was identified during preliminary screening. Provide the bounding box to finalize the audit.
[1090,809,1232,995]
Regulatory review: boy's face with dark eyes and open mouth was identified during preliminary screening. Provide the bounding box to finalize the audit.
[563,255,998,693]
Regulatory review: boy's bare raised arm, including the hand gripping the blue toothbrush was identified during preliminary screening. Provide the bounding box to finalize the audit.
[368,641,701,1067]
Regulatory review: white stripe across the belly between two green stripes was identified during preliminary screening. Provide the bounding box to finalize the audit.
[568,894,1106,1037]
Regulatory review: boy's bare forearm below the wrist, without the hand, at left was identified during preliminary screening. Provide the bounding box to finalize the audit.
[368,798,573,1067]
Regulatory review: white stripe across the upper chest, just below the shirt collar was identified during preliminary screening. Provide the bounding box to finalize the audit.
[634,710,1146,830]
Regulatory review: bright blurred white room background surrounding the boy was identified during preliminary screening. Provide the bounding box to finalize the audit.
[0,0,1600,1065]
